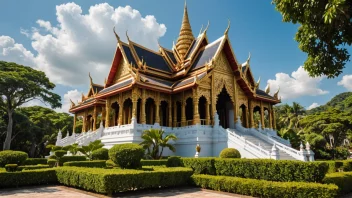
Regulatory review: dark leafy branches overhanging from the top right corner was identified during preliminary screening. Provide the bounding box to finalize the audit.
[272,0,352,78]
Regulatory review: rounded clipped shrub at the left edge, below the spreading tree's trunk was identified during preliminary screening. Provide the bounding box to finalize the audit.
[0,150,28,167]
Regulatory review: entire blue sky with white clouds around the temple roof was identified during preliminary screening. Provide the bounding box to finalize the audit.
[0,0,352,112]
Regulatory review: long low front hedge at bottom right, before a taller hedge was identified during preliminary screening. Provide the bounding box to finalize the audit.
[191,175,338,198]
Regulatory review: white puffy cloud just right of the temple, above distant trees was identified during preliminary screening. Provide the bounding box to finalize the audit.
[268,66,329,100]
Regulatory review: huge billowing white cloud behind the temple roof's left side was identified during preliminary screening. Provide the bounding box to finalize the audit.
[0,3,166,86]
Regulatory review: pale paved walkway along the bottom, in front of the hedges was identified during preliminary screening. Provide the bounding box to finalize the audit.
[0,186,249,198]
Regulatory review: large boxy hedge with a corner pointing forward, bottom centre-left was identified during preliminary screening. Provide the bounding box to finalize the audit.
[56,167,193,195]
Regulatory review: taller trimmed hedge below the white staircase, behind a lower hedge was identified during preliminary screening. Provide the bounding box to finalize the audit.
[214,158,328,182]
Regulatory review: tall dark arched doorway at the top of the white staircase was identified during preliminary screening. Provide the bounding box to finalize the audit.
[216,87,235,129]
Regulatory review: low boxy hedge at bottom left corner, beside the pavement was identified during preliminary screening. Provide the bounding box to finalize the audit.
[0,169,57,188]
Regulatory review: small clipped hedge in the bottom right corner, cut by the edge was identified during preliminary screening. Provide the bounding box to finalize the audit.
[323,172,352,195]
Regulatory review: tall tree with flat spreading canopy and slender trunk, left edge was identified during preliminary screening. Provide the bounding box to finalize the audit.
[0,61,61,150]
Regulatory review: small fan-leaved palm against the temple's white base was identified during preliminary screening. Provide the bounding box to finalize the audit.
[140,129,177,159]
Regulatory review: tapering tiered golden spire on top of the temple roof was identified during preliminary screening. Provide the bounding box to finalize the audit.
[176,2,194,59]
